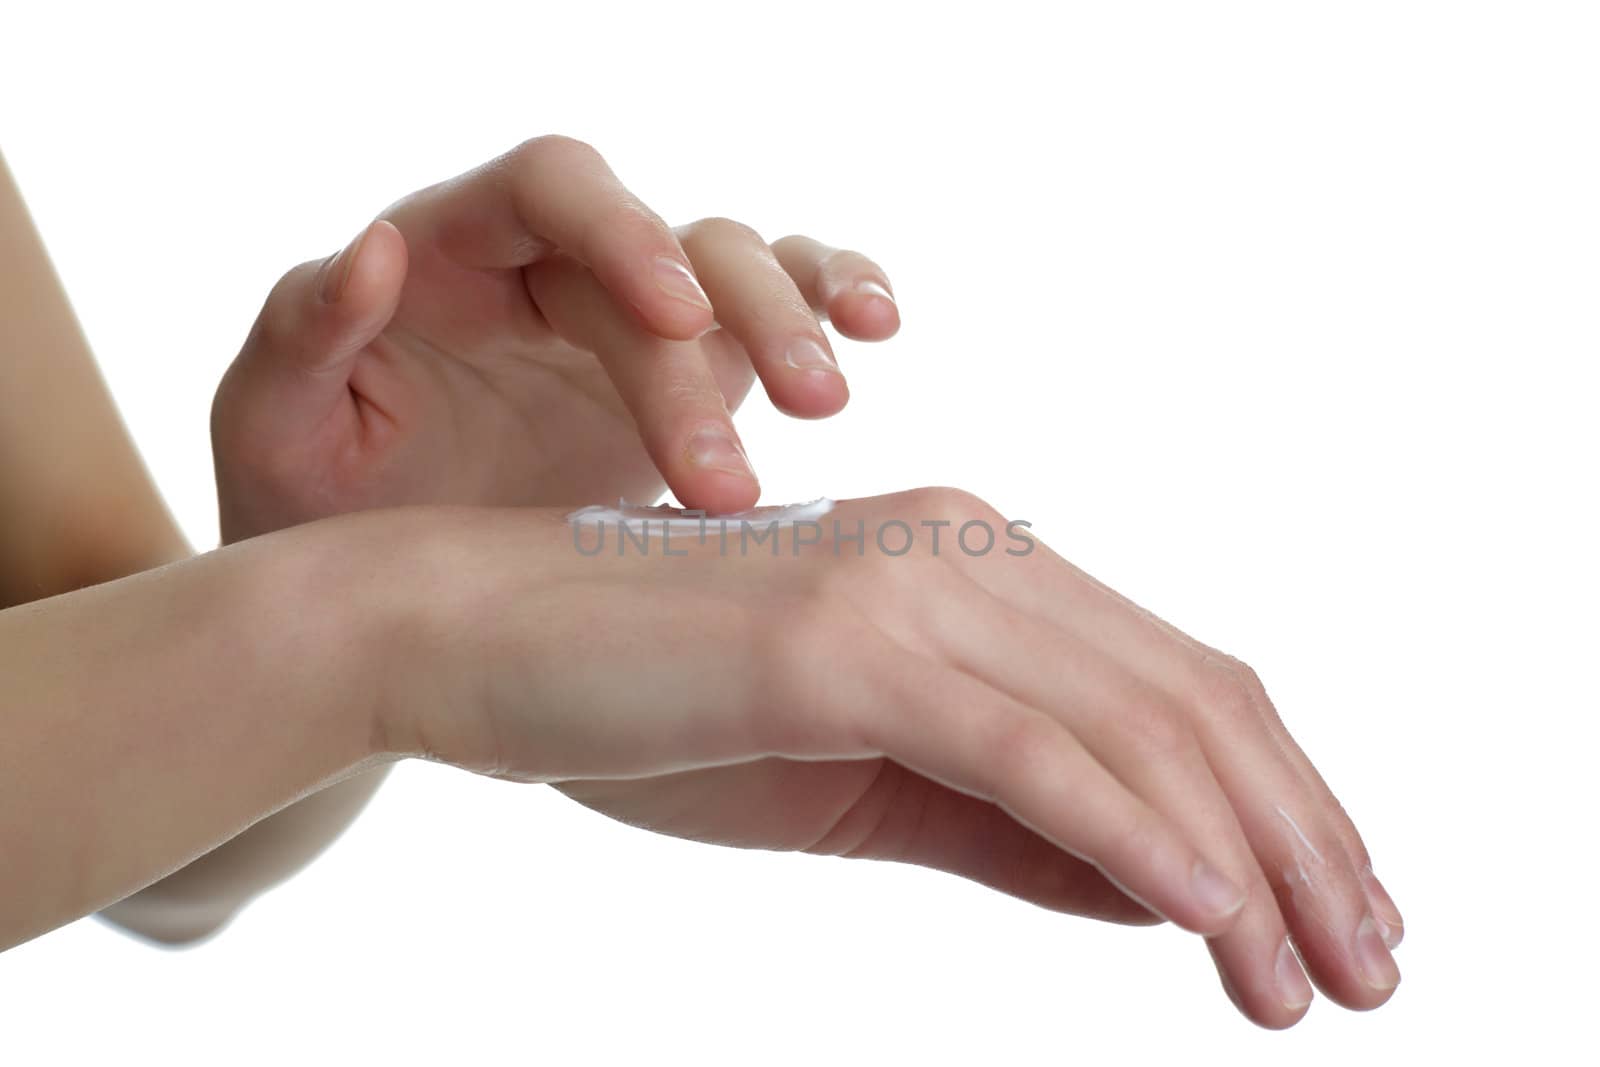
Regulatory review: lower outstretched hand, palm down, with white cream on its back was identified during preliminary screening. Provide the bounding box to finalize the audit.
[384,490,1402,1027]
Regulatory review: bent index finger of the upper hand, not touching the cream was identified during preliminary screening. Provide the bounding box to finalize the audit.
[386,134,712,341]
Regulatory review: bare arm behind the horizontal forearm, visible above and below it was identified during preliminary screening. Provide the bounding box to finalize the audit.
[0,151,384,942]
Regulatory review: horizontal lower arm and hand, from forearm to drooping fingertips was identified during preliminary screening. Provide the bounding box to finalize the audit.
[0,490,1398,1027]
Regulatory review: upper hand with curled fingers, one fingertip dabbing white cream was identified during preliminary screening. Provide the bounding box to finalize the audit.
[211,138,899,541]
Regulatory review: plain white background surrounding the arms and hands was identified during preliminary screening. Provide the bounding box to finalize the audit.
[0,0,1600,1065]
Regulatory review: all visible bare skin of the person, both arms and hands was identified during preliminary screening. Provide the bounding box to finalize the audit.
[0,138,1403,1027]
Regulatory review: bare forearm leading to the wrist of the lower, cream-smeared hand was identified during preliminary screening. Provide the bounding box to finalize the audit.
[0,525,390,947]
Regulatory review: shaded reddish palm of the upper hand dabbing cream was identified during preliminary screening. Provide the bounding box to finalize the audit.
[320,246,752,509]
